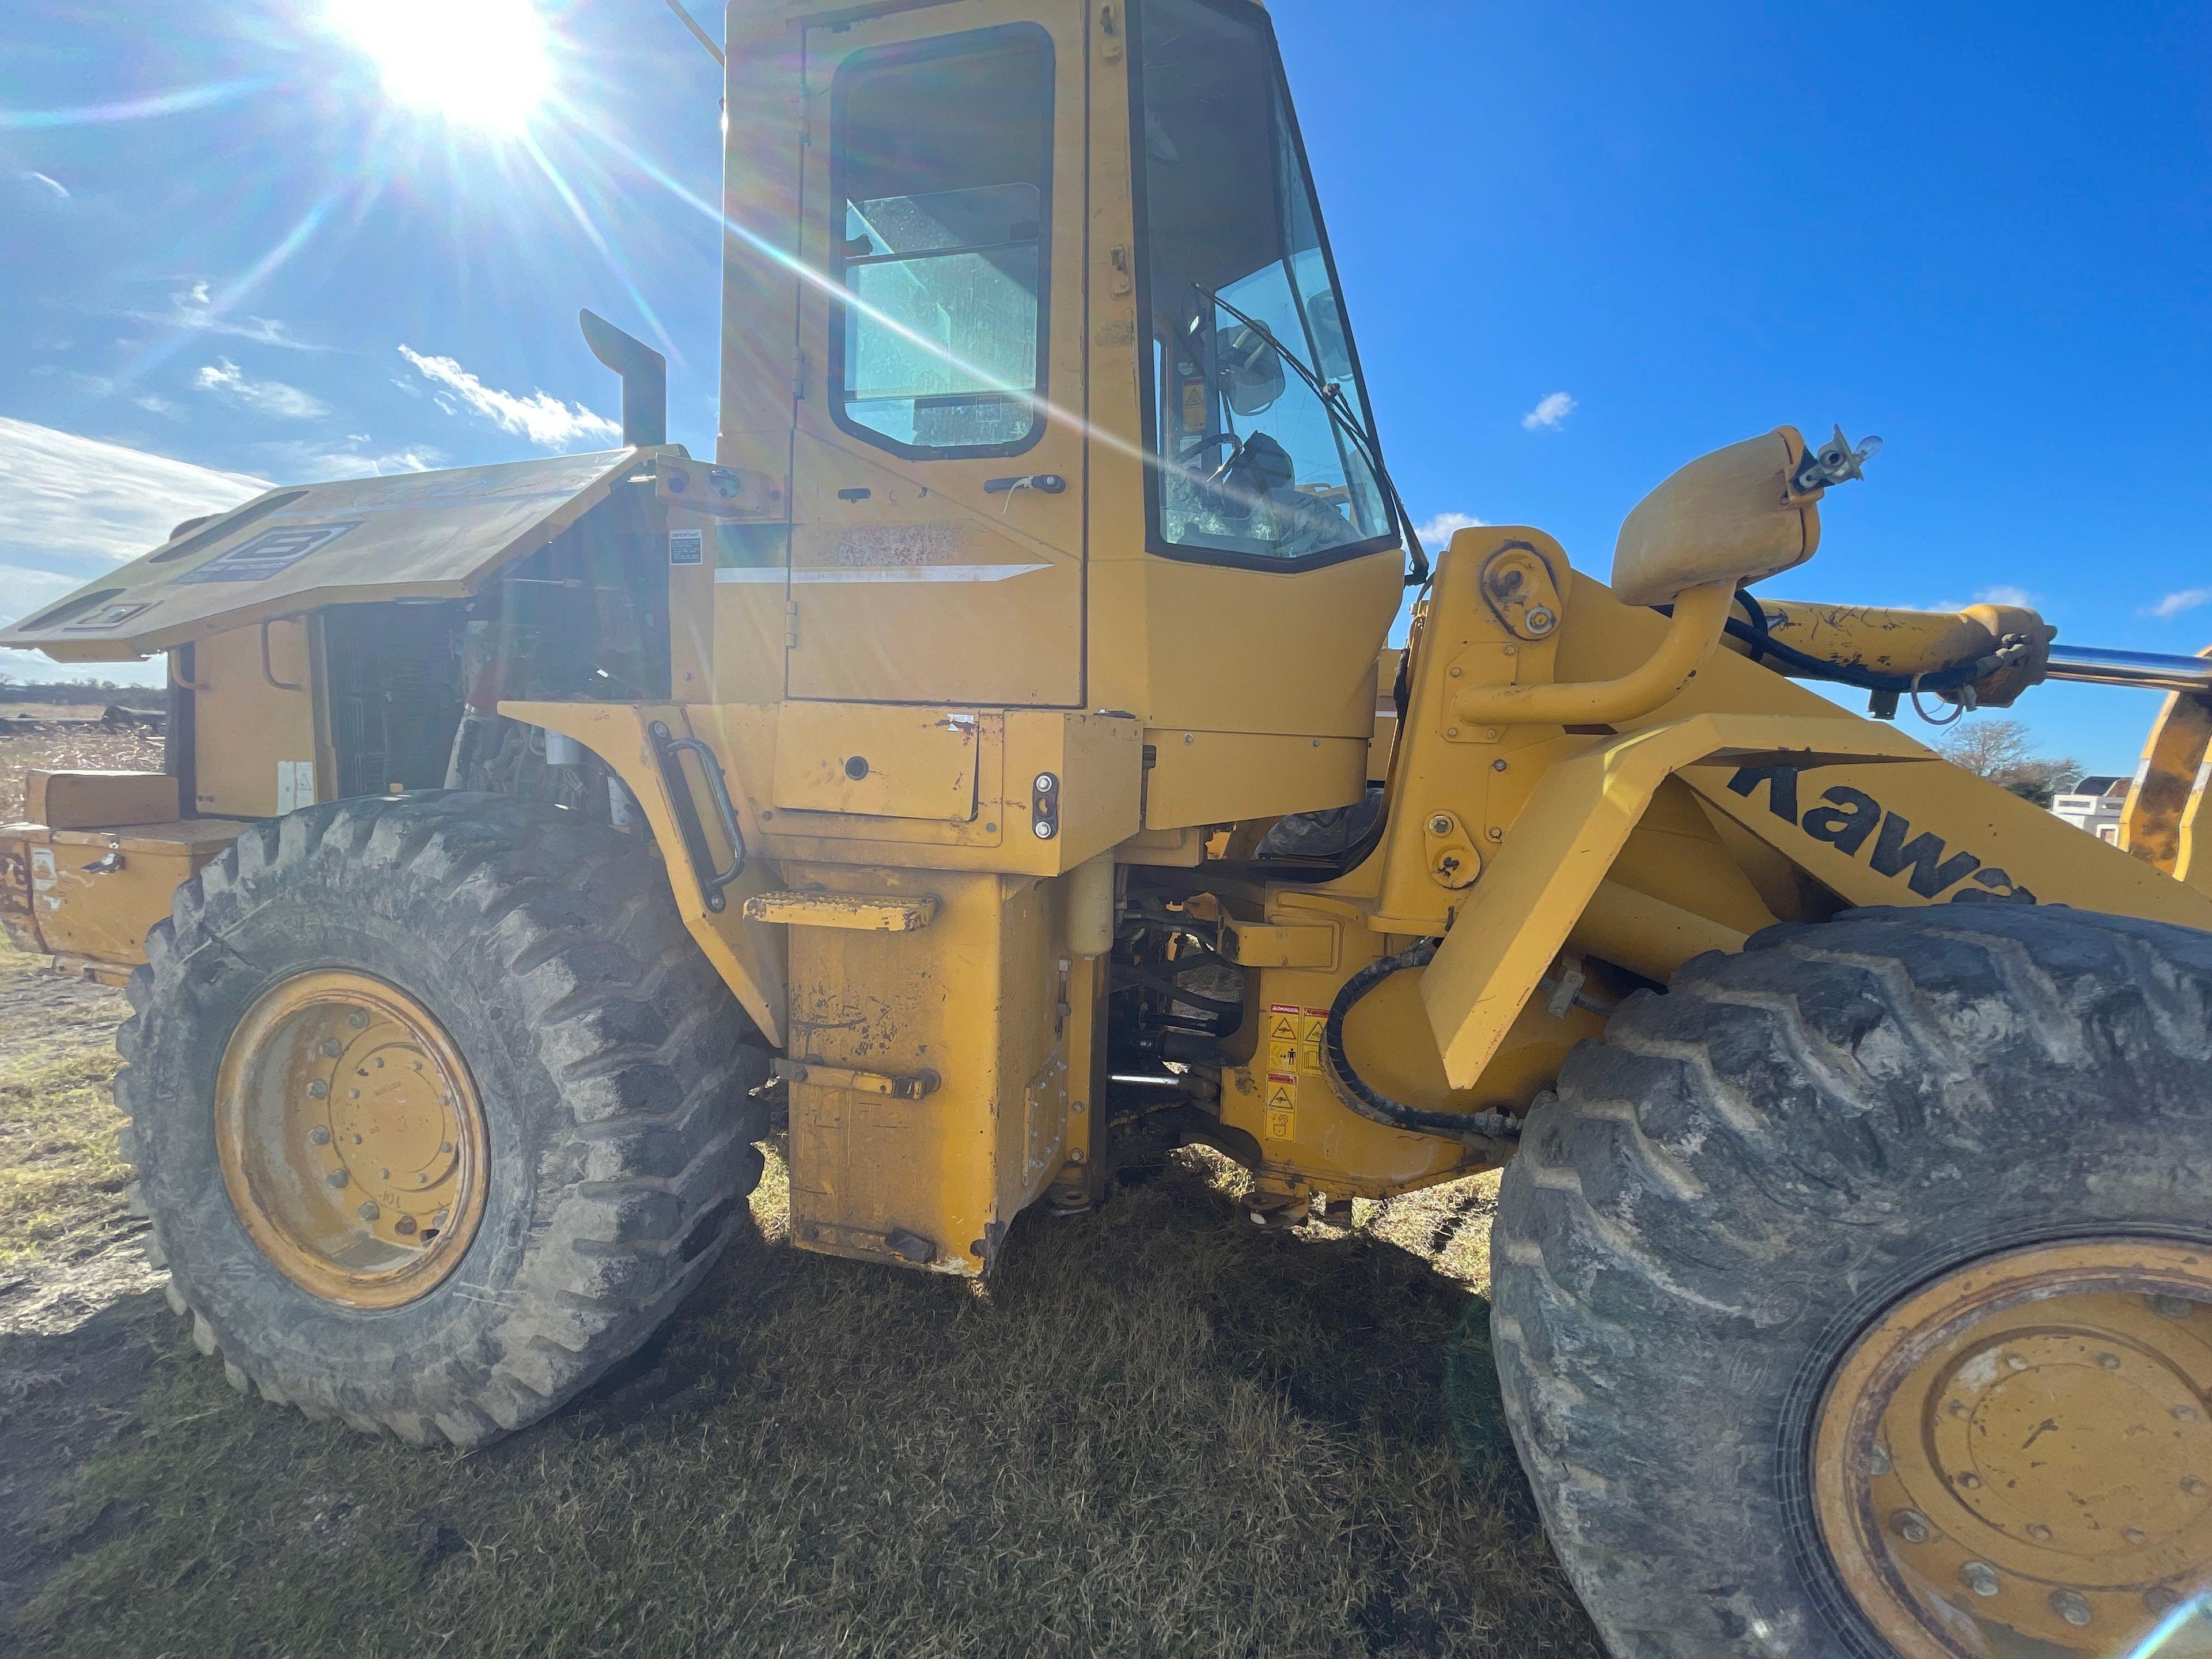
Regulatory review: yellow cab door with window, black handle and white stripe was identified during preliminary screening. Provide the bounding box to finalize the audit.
[785,0,1086,708]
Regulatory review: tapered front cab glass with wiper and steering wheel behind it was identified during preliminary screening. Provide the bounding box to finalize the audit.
[1132,0,1396,566]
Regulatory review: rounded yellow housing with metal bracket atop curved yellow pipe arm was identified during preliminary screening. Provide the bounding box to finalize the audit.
[1612,427,1831,604]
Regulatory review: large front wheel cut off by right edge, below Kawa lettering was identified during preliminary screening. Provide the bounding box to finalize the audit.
[1491,905,2212,1659]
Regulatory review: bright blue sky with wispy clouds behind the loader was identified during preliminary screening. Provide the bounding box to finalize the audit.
[0,0,2212,770]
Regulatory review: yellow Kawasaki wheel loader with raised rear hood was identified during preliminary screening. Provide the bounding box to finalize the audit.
[0,0,2212,1659]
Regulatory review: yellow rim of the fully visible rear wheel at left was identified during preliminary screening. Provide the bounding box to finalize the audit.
[214,969,487,1307]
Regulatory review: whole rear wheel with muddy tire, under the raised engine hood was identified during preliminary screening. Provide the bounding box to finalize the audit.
[115,794,767,1446]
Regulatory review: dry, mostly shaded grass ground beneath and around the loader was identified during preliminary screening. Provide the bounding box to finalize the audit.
[0,911,1597,1659]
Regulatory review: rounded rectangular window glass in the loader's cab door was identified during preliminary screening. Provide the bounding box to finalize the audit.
[830,24,1053,458]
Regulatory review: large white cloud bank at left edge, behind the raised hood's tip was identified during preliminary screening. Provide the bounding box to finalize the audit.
[0,416,268,681]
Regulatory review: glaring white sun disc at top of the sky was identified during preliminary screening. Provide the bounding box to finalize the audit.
[329,0,553,132]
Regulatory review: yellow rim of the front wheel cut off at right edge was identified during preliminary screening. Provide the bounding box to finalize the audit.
[1814,1238,2212,1659]
